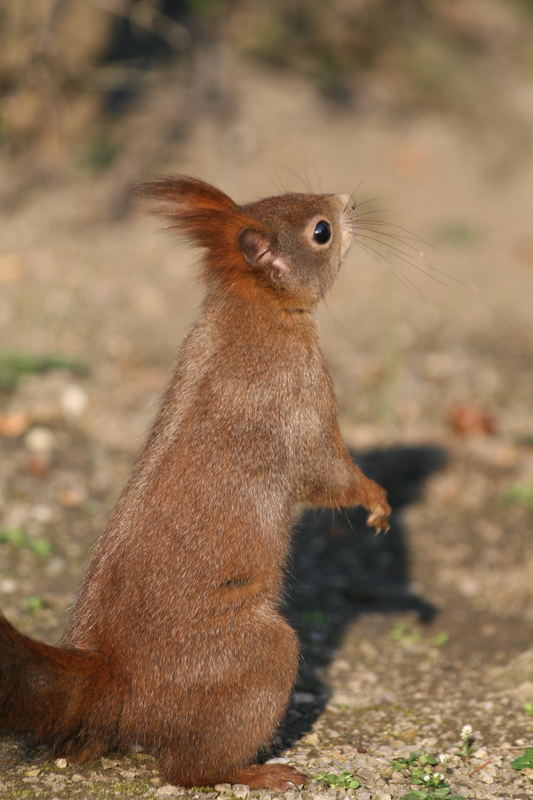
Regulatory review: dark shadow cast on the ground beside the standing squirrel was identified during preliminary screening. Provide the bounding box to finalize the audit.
[277,445,447,751]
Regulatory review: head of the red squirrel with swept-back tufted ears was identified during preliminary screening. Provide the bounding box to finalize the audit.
[135,176,355,311]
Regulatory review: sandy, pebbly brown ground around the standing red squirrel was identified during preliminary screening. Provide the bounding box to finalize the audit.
[0,69,533,800]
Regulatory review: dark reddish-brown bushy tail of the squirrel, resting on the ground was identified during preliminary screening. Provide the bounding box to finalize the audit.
[0,614,111,760]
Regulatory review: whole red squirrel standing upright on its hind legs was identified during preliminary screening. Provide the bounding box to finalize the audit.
[0,176,390,791]
